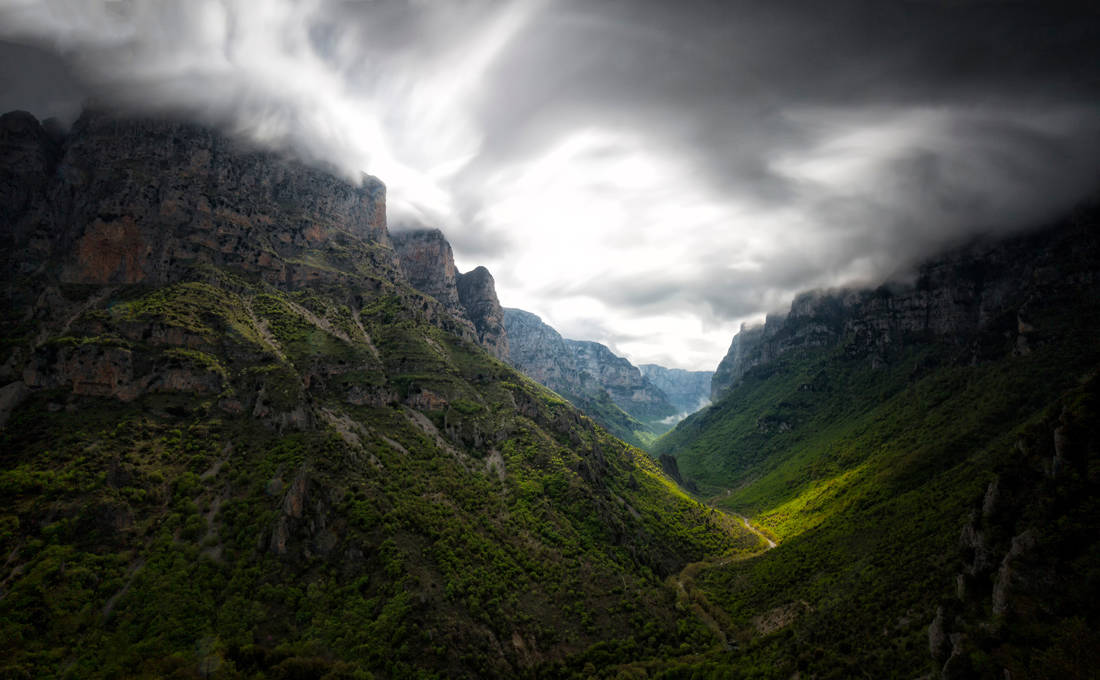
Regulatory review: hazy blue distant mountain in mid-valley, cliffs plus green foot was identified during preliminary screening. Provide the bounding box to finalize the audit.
[504,308,685,446]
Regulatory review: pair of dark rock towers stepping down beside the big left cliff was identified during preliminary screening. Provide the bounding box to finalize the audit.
[393,229,508,361]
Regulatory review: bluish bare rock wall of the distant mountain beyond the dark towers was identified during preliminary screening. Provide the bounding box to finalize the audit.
[504,309,679,431]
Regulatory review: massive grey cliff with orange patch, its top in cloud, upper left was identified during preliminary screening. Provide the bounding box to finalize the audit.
[3,107,396,286]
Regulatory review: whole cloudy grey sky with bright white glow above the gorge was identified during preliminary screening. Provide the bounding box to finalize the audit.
[0,0,1100,370]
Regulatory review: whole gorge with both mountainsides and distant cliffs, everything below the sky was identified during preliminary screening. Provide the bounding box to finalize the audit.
[0,104,1100,679]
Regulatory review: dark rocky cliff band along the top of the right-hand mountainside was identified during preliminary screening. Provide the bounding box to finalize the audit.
[711,209,1100,399]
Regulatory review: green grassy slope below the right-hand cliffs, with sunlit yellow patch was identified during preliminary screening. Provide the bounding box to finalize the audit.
[656,286,1100,678]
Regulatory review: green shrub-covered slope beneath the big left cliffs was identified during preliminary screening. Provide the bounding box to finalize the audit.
[0,271,757,678]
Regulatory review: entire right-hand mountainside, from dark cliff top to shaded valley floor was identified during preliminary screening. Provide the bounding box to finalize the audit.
[656,208,1100,678]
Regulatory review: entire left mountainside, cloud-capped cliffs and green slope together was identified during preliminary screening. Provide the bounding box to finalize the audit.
[0,108,760,678]
